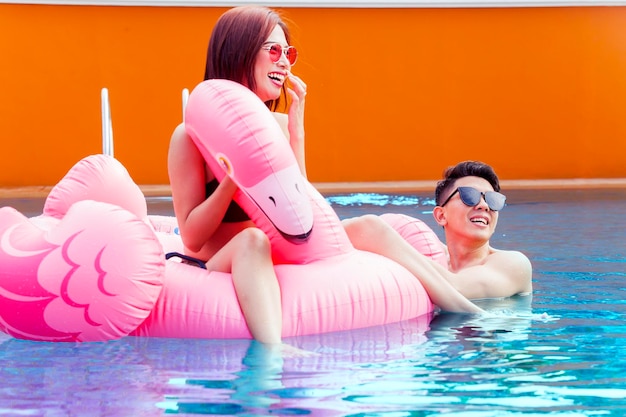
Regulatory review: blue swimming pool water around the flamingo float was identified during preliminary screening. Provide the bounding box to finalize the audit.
[0,189,626,417]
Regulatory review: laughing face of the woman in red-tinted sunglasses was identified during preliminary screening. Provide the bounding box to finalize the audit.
[254,25,291,102]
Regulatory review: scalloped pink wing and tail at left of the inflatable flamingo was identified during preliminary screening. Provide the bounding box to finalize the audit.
[0,158,165,341]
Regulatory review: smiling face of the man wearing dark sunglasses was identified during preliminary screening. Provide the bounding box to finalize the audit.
[433,177,498,240]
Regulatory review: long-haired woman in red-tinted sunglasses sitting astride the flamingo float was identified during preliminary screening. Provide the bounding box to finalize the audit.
[168,6,306,344]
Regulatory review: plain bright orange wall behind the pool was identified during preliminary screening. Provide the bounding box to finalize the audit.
[0,4,626,186]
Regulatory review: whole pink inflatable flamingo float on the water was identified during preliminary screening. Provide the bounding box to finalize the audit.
[0,80,446,341]
